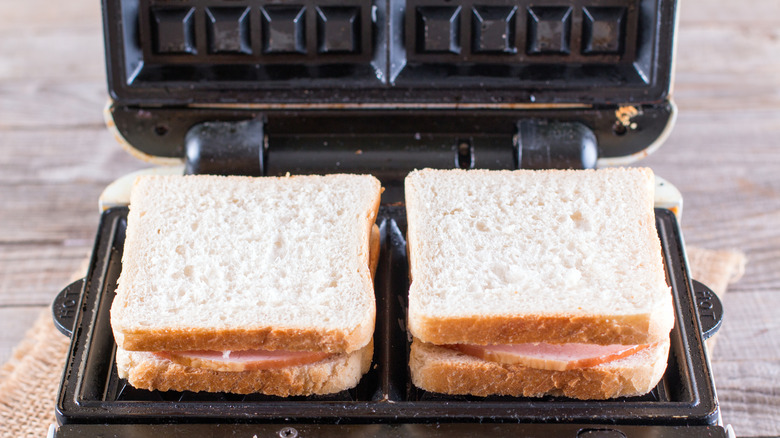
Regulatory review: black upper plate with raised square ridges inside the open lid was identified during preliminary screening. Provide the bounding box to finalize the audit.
[103,0,676,105]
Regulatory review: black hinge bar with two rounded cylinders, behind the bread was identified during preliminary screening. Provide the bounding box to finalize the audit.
[184,118,598,201]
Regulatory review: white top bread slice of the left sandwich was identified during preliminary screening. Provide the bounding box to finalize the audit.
[111,175,382,352]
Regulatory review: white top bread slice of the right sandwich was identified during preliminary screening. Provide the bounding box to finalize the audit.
[406,169,674,345]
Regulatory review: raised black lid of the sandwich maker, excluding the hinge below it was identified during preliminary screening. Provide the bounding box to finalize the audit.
[102,0,677,165]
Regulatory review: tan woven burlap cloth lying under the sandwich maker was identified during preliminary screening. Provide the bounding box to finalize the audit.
[0,248,745,437]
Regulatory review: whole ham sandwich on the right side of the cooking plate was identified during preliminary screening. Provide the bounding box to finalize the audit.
[405,169,674,399]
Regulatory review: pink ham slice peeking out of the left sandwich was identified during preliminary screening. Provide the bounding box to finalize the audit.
[155,350,330,372]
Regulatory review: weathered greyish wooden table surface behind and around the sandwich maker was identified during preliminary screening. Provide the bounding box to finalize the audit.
[0,0,780,436]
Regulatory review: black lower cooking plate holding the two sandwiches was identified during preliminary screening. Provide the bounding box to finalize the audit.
[51,206,723,436]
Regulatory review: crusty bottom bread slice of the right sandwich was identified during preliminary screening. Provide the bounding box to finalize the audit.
[409,339,669,400]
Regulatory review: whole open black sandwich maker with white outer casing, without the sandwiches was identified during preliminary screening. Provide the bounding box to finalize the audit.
[50,0,733,438]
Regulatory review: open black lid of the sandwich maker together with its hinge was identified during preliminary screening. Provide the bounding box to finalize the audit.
[103,0,676,200]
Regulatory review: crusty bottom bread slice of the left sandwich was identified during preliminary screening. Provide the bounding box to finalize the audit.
[116,342,374,397]
